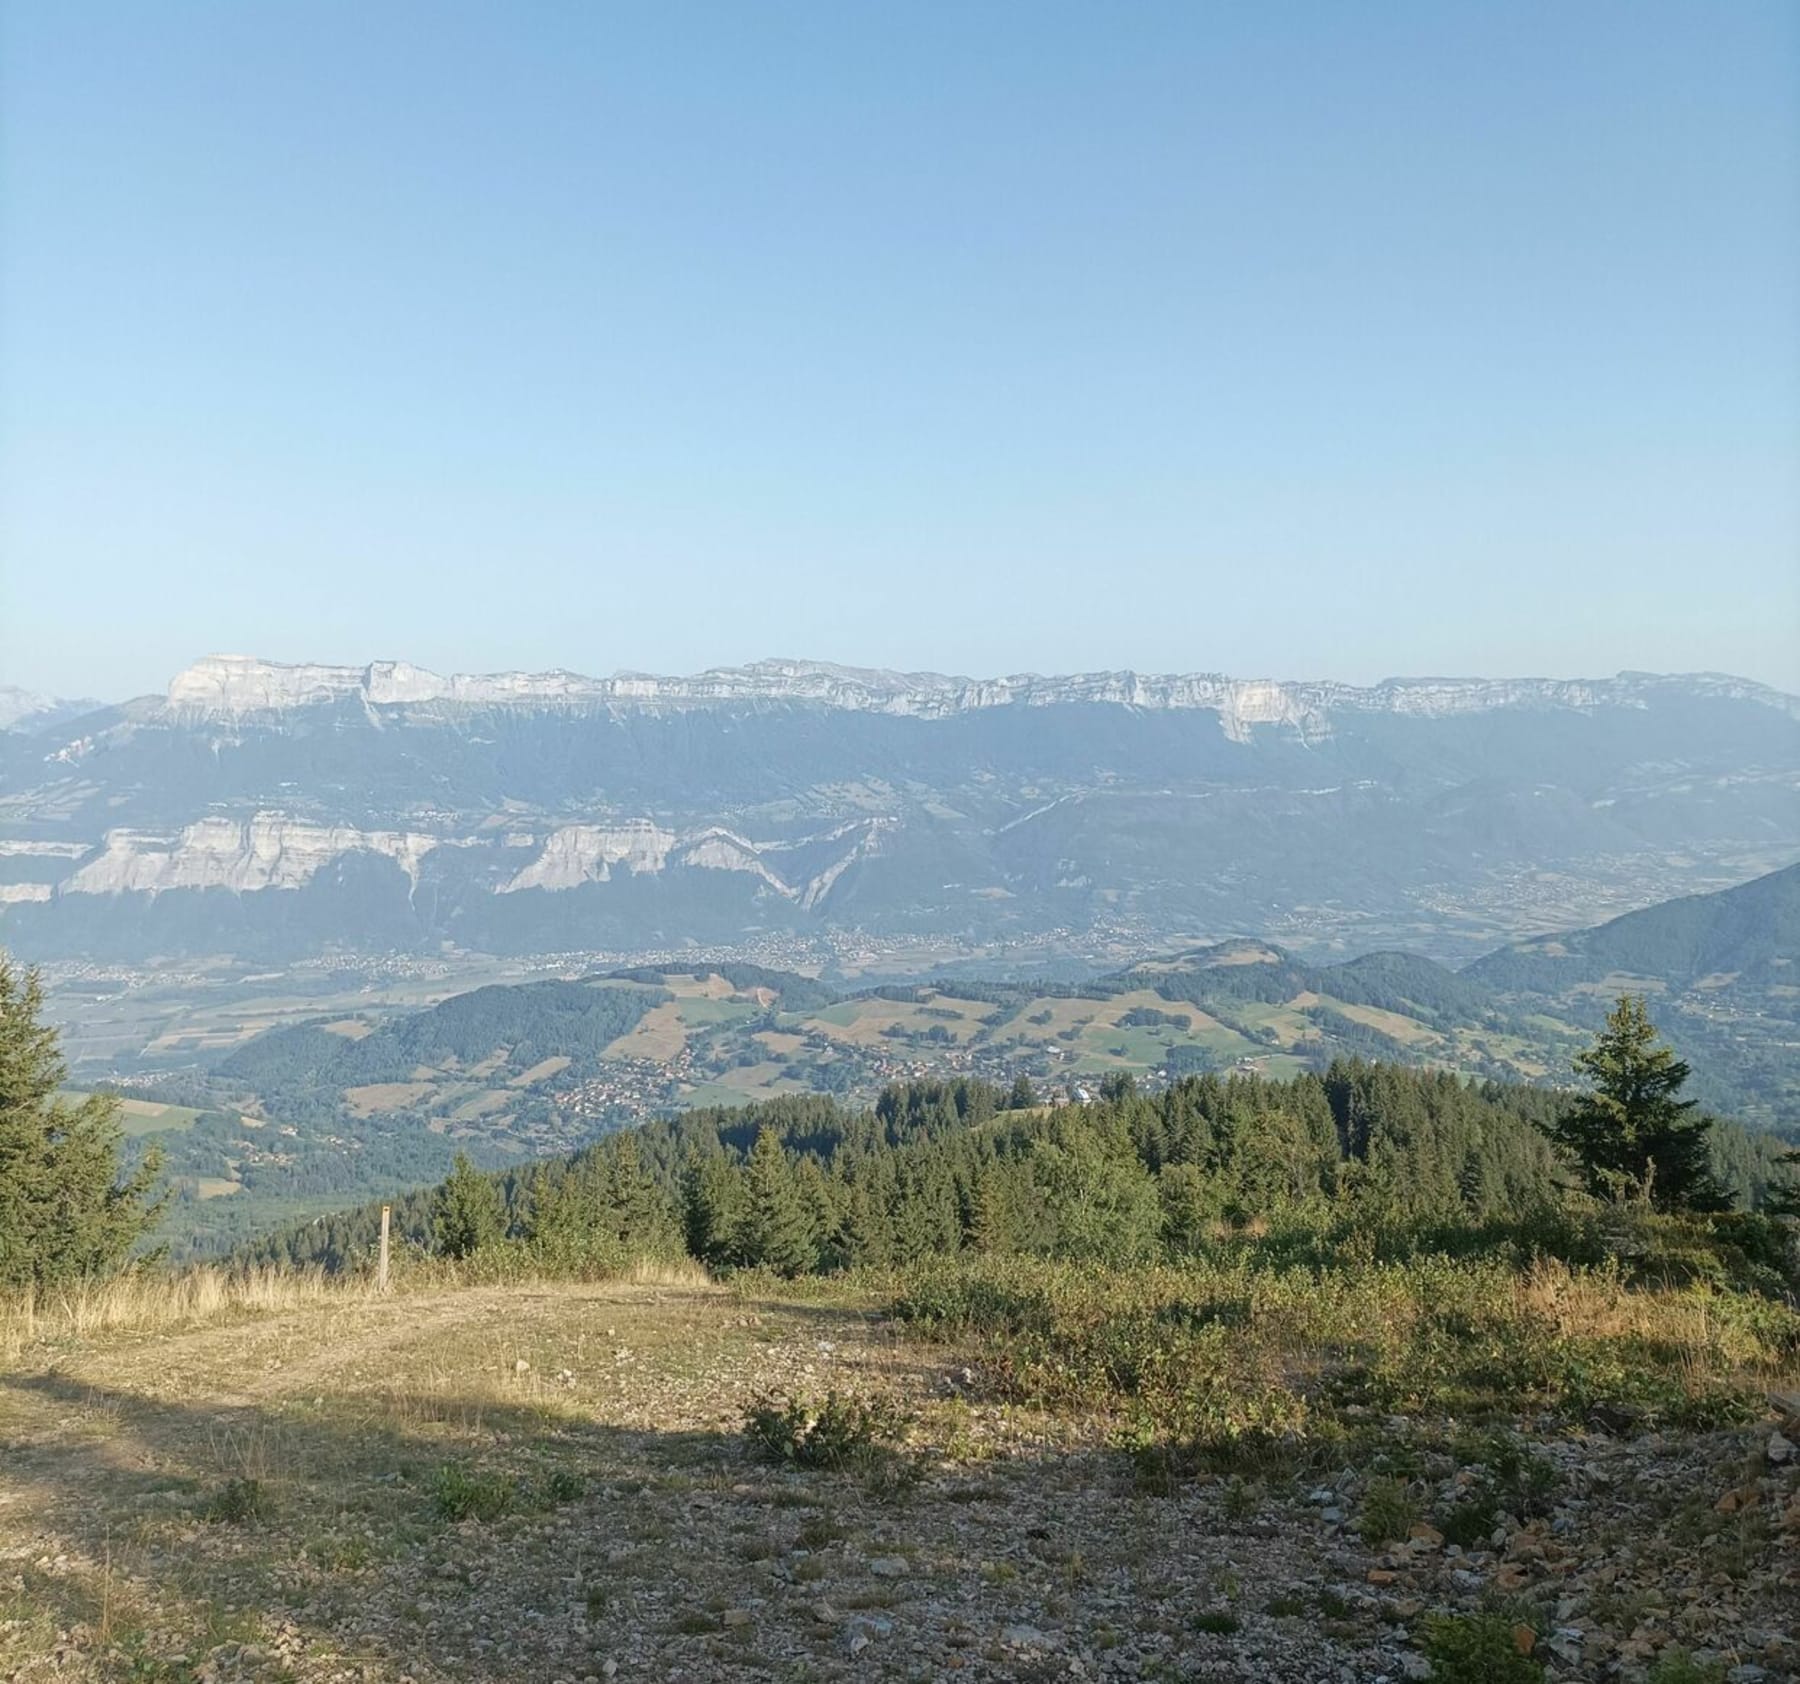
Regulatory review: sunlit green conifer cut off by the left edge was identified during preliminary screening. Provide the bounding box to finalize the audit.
[0,954,162,1288]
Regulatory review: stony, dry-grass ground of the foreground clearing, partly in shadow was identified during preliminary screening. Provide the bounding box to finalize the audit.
[0,1285,1800,1684]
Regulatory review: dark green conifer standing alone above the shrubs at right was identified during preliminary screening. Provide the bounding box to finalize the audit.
[1550,995,1726,1211]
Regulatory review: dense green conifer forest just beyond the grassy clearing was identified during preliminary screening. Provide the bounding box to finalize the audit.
[247,1060,1782,1274]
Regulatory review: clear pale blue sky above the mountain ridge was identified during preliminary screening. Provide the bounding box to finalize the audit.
[0,0,1800,698]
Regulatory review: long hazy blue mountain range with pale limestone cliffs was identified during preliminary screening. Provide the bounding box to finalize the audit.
[0,657,1800,963]
